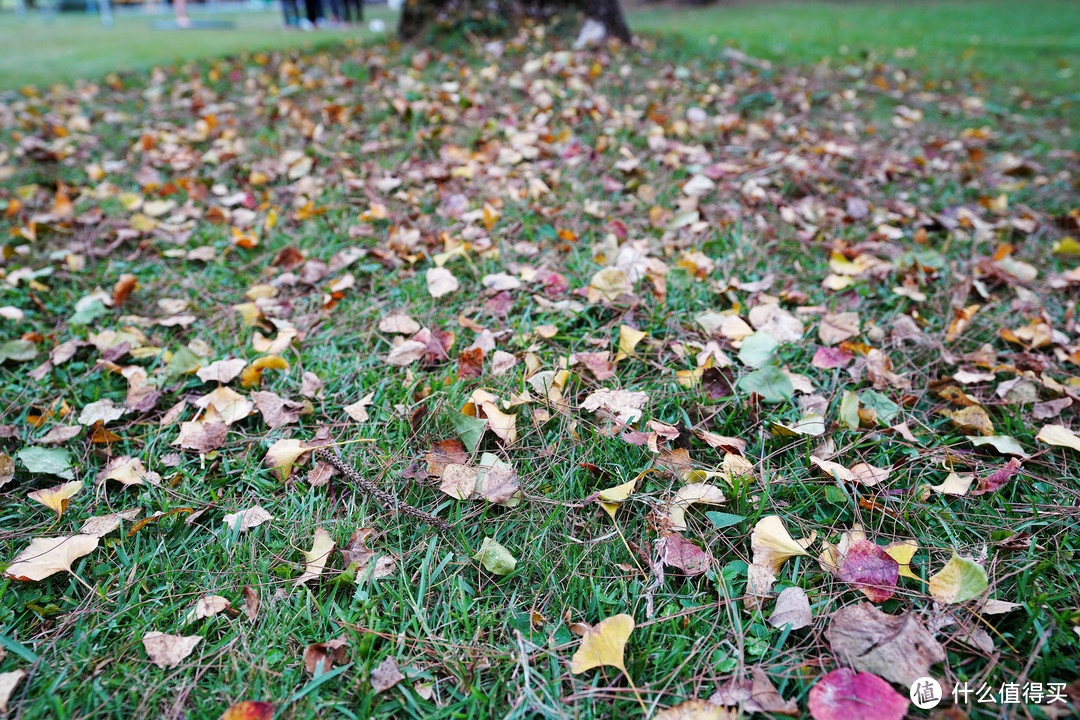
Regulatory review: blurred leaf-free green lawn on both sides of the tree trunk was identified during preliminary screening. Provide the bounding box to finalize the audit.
[0,0,1080,98]
